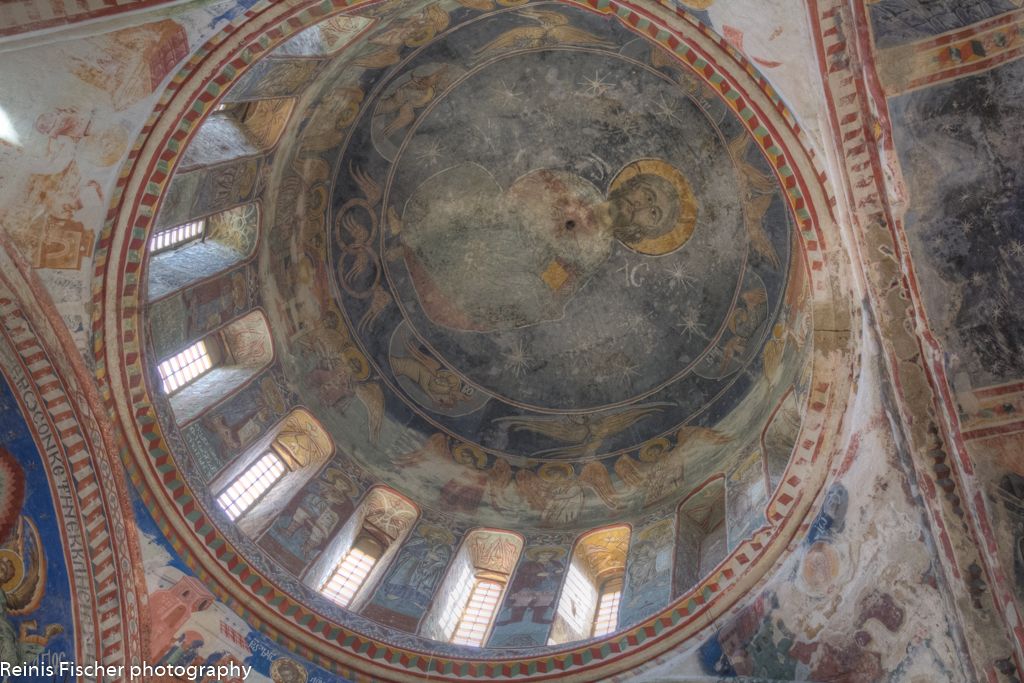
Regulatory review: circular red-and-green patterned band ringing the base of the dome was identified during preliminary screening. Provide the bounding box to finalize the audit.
[93,2,856,680]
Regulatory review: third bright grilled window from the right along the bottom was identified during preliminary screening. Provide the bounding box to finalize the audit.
[304,486,420,611]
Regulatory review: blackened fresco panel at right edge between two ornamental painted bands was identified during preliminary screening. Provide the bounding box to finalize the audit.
[890,57,1024,391]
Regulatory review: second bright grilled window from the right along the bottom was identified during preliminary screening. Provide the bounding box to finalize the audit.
[421,529,522,647]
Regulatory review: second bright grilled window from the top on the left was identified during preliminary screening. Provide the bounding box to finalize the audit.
[157,310,273,424]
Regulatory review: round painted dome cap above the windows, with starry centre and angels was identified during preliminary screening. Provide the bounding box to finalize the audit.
[262,3,807,528]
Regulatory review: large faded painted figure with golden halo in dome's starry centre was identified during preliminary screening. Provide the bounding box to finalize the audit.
[398,159,696,332]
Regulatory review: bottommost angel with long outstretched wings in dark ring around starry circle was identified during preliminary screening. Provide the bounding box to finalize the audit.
[495,403,671,458]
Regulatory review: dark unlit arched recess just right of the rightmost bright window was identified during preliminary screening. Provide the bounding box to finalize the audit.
[673,476,728,596]
